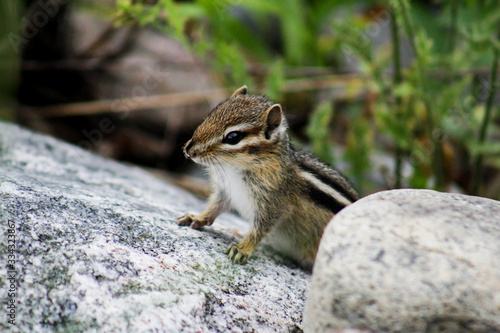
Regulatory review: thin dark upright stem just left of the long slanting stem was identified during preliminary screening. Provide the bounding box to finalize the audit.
[391,14,403,188]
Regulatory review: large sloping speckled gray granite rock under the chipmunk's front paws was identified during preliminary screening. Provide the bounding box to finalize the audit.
[0,122,309,332]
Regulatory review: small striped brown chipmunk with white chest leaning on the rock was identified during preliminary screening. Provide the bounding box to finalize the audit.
[178,86,358,269]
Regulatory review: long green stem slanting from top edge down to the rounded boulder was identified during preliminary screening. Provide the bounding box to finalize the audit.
[398,0,445,190]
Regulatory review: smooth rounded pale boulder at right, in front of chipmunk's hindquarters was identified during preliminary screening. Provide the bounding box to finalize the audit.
[304,190,500,332]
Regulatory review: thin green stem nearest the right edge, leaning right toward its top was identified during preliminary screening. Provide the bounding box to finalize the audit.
[472,48,500,195]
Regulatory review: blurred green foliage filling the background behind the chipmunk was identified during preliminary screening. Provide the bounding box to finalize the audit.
[117,0,500,196]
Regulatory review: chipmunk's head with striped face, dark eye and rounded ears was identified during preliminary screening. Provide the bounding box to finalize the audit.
[184,86,287,168]
